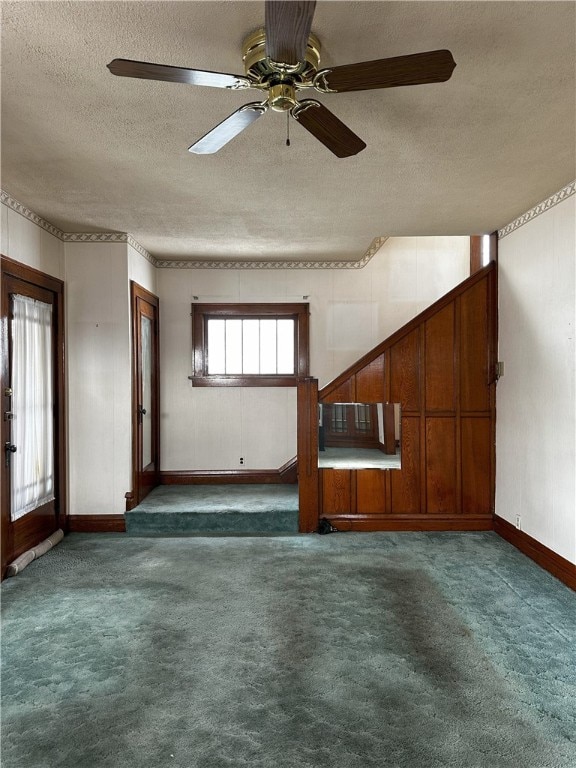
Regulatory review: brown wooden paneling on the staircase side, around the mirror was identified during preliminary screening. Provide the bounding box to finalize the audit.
[320,264,498,530]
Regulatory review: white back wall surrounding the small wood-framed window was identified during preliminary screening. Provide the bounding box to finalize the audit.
[157,237,469,471]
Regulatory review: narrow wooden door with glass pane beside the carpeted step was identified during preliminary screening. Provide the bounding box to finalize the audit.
[128,282,160,508]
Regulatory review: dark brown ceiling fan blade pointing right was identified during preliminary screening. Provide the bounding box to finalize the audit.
[314,50,456,93]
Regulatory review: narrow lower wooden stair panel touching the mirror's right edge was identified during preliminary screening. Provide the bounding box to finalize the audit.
[388,416,424,515]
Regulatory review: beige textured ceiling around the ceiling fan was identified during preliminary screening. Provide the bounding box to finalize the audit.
[1,0,576,260]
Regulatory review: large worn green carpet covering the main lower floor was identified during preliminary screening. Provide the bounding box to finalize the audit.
[2,533,576,768]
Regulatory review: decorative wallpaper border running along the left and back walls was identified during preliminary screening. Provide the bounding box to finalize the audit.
[0,189,388,269]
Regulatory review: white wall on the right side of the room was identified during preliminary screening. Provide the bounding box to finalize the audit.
[496,196,576,563]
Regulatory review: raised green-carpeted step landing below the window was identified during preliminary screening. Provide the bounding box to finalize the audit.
[125,483,298,536]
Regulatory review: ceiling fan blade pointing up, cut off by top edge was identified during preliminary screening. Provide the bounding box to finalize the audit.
[265,0,316,65]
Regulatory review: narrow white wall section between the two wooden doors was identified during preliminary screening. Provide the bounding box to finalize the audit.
[65,243,132,515]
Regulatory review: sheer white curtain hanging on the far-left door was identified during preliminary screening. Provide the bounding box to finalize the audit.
[10,295,54,520]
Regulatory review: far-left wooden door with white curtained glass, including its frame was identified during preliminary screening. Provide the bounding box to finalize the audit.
[0,257,66,577]
